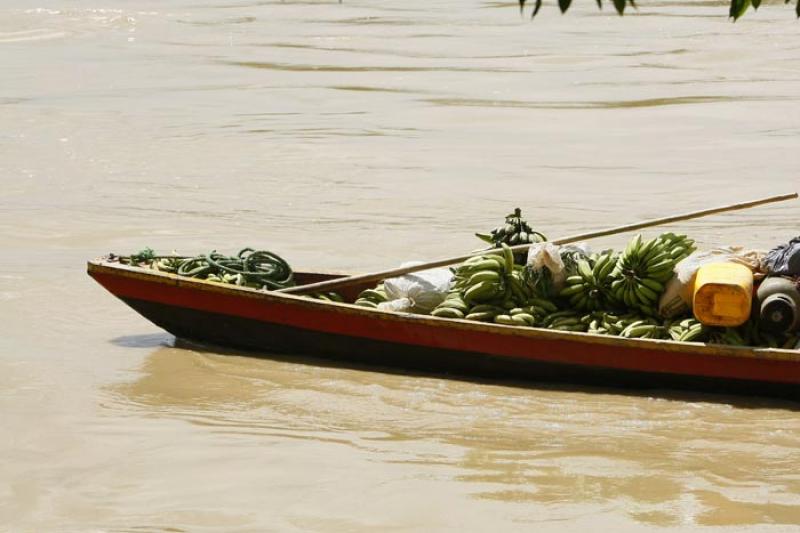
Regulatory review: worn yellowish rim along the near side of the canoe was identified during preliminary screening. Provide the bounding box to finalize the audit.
[87,258,800,363]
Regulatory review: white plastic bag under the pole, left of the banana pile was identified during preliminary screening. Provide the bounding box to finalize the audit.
[378,262,453,314]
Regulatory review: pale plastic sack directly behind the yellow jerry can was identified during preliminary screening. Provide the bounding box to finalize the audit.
[658,246,765,318]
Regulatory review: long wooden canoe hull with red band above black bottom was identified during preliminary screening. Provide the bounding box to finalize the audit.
[88,259,800,400]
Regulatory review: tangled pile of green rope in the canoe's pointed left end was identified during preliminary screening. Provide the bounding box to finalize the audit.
[120,248,295,290]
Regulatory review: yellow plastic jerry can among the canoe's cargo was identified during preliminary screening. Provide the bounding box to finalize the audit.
[692,263,753,326]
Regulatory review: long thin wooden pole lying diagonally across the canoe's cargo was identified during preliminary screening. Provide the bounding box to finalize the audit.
[278,192,798,294]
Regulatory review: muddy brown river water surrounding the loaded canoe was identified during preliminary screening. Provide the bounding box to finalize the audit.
[0,0,800,532]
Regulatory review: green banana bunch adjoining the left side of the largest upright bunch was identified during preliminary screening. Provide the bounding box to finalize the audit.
[559,251,617,311]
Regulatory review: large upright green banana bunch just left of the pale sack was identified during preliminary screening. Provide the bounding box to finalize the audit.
[611,233,695,316]
